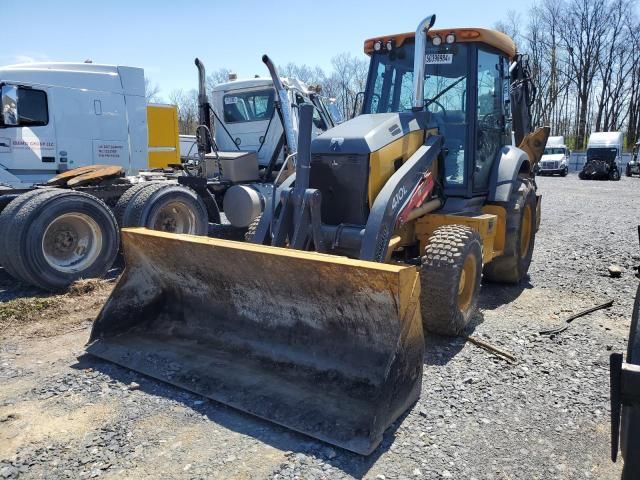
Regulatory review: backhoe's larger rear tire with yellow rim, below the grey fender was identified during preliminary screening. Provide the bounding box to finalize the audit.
[484,178,537,284]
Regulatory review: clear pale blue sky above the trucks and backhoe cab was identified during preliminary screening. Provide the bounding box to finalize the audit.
[0,0,529,98]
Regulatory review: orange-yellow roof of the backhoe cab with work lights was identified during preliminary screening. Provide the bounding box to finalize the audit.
[364,28,516,59]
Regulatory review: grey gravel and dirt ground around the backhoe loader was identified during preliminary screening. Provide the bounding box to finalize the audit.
[0,175,640,479]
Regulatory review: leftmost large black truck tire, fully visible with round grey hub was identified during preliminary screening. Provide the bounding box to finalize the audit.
[3,189,120,291]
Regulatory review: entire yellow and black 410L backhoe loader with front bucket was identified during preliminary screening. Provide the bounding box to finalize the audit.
[87,16,549,454]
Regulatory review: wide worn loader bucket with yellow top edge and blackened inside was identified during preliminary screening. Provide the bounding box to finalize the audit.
[87,229,424,455]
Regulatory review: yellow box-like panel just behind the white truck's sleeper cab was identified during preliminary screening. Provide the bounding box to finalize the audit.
[147,104,180,168]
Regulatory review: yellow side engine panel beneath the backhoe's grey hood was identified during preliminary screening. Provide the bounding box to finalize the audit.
[368,130,425,206]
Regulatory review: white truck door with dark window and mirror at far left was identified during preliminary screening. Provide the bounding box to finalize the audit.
[0,84,58,186]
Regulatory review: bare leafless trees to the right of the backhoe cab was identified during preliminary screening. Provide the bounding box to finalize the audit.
[495,0,640,149]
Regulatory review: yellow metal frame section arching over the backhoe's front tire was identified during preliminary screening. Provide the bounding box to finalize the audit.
[415,213,502,263]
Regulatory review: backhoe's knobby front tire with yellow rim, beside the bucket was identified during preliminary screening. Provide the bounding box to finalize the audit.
[420,225,482,336]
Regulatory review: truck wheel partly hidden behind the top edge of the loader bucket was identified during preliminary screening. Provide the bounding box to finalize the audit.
[122,183,209,235]
